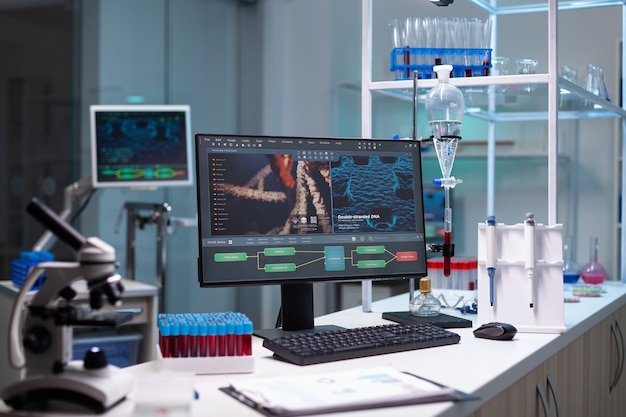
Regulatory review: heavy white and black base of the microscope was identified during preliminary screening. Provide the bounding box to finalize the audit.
[2,361,134,413]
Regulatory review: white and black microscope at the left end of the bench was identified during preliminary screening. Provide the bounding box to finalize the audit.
[2,199,134,413]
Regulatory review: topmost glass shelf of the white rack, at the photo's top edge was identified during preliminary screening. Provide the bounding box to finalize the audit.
[469,0,625,15]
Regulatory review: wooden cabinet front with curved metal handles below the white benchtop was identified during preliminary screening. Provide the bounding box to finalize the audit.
[472,307,626,417]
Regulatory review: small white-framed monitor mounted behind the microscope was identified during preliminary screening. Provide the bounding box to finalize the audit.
[89,105,193,189]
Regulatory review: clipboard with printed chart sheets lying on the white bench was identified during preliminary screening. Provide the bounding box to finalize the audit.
[220,366,479,417]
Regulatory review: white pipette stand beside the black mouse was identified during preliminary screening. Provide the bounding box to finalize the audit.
[477,219,565,333]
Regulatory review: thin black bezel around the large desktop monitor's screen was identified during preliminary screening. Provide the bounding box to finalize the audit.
[194,133,428,288]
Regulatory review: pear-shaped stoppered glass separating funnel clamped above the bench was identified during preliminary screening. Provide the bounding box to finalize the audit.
[425,65,465,179]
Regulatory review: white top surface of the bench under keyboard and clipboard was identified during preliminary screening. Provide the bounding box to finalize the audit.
[0,283,626,417]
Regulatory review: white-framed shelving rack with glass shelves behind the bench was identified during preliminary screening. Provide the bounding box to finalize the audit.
[360,0,626,286]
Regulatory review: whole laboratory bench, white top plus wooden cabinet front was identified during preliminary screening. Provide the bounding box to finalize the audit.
[0,282,626,417]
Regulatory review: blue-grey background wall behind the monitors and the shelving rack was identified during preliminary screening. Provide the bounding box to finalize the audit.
[75,0,621,326]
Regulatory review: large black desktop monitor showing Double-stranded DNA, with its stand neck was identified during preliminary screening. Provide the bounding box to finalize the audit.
[195,134,427,337]
